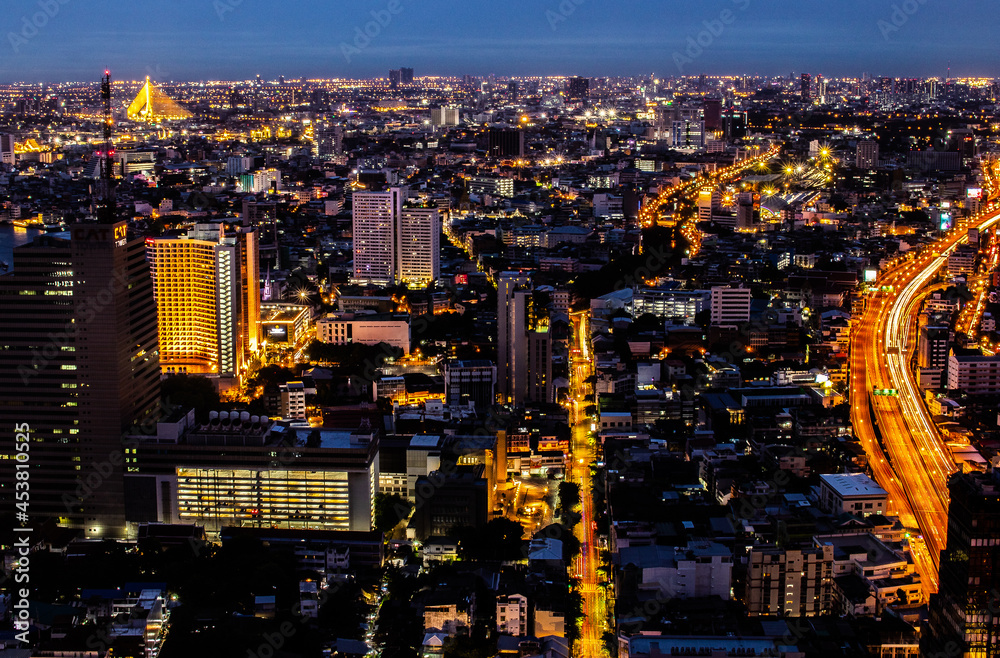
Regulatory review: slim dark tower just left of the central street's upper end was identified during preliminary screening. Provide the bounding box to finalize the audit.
[497,272,554,405]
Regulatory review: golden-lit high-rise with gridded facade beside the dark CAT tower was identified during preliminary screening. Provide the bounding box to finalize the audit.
[146,224,260,388]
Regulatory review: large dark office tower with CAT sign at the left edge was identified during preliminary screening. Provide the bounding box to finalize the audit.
[0,222,160,538]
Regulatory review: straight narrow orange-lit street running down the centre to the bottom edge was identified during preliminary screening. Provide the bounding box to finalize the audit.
[567,314,610,658]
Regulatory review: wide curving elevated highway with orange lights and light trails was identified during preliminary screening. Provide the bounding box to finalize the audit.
[850,182,1000,593]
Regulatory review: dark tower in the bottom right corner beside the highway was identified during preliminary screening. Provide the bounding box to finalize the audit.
[920,469,1000,658]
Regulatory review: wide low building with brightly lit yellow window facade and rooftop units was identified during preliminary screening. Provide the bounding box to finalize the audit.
[127,412,379,532]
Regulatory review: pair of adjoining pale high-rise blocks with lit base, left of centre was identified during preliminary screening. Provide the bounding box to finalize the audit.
[354,187,441,287]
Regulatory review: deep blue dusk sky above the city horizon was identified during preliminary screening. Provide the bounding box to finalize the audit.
[0,0,1000,83]
